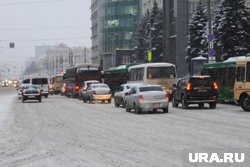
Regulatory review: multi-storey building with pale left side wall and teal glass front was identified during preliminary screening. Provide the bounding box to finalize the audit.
[91,0,141,70]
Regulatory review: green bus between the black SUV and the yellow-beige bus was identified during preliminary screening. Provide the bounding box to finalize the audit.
[203,56,249,102]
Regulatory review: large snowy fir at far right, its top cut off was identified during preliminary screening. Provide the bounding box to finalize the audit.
[215,0,250,60]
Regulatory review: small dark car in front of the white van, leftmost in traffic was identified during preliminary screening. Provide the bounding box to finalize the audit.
[22,85,42,103]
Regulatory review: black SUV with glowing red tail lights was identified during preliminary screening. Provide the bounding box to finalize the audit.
[172,75,218,109]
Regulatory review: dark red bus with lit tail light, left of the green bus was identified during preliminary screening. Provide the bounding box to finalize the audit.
[64,63,103,97]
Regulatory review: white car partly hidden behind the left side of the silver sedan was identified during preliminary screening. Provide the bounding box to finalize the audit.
[114,83,143,107]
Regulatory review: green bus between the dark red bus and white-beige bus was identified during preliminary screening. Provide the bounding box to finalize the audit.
[104,64,135,94]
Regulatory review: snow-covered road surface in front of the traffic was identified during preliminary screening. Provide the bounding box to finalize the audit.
[0,89,250,167]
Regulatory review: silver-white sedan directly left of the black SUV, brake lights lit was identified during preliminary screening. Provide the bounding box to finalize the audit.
[125,85,169,114]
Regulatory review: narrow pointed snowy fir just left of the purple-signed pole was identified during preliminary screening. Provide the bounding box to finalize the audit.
[186,0,208,62]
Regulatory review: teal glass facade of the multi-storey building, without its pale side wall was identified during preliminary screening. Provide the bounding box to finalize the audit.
[101,0,140,70]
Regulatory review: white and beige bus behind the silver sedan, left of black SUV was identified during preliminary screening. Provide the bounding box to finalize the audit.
[128,63,177,99]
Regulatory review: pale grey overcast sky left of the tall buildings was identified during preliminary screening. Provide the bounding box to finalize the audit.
[0,0,91,64]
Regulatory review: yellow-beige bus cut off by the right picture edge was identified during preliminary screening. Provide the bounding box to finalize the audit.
[234,57,250,111]
